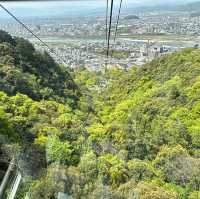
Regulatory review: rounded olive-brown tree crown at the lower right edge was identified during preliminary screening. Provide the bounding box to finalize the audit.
[154,145,200,186]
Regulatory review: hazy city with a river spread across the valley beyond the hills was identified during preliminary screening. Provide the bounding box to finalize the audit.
[0,1,200,70]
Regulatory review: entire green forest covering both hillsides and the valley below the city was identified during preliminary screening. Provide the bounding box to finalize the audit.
[0,32,200,199]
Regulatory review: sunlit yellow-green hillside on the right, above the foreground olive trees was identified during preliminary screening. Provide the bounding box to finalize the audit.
[94,49,200,158]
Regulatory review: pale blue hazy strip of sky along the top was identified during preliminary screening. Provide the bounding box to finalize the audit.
[0,0,197,18]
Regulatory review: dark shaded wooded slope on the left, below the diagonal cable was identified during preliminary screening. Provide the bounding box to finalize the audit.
[0,31,79,104]
